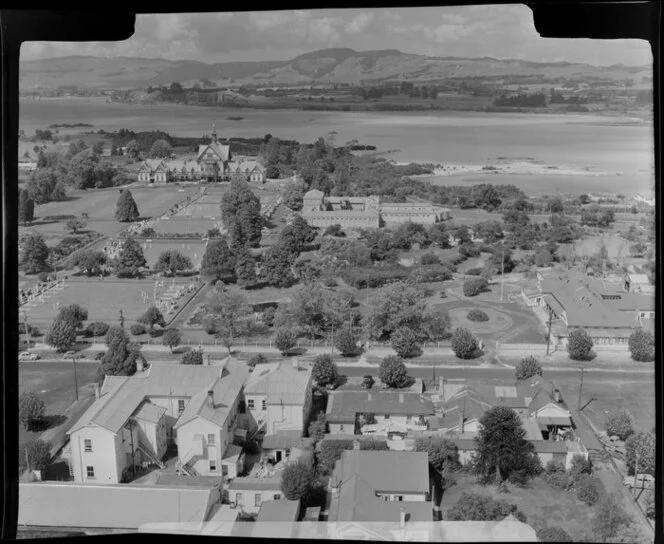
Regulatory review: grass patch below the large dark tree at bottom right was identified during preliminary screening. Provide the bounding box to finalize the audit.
[441,474,593,542]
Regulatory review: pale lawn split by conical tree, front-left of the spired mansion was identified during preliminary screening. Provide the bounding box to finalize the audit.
[35,185,198,223]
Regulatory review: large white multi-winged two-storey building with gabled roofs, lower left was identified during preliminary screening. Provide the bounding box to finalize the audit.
[68,358,248,484]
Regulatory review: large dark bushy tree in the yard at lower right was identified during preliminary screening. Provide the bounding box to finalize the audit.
[475,406,536,483]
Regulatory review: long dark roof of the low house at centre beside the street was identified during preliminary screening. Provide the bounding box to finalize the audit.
[326,389,435,423]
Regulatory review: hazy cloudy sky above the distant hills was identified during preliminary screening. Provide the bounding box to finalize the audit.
[21,5,652,65]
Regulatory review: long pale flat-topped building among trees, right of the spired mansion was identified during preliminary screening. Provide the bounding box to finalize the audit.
[302,189,449,228]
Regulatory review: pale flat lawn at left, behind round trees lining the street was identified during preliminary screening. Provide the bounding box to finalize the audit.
[20,279,197,331]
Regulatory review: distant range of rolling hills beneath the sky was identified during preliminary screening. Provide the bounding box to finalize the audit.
[20,48,652,91]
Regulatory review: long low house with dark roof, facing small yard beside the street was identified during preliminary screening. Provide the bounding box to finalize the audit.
[326,389,435,437]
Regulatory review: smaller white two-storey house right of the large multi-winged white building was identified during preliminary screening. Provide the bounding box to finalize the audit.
[244,359,312,435]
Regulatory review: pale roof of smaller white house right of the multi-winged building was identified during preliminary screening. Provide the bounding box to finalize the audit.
[244,361,311,405]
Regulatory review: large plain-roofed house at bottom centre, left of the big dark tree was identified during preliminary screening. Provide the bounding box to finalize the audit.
[326,449,434,522]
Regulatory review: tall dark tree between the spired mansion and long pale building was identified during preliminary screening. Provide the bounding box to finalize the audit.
[221,179,263,247]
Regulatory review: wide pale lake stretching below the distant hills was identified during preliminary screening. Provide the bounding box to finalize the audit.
[19,98,654,198]
